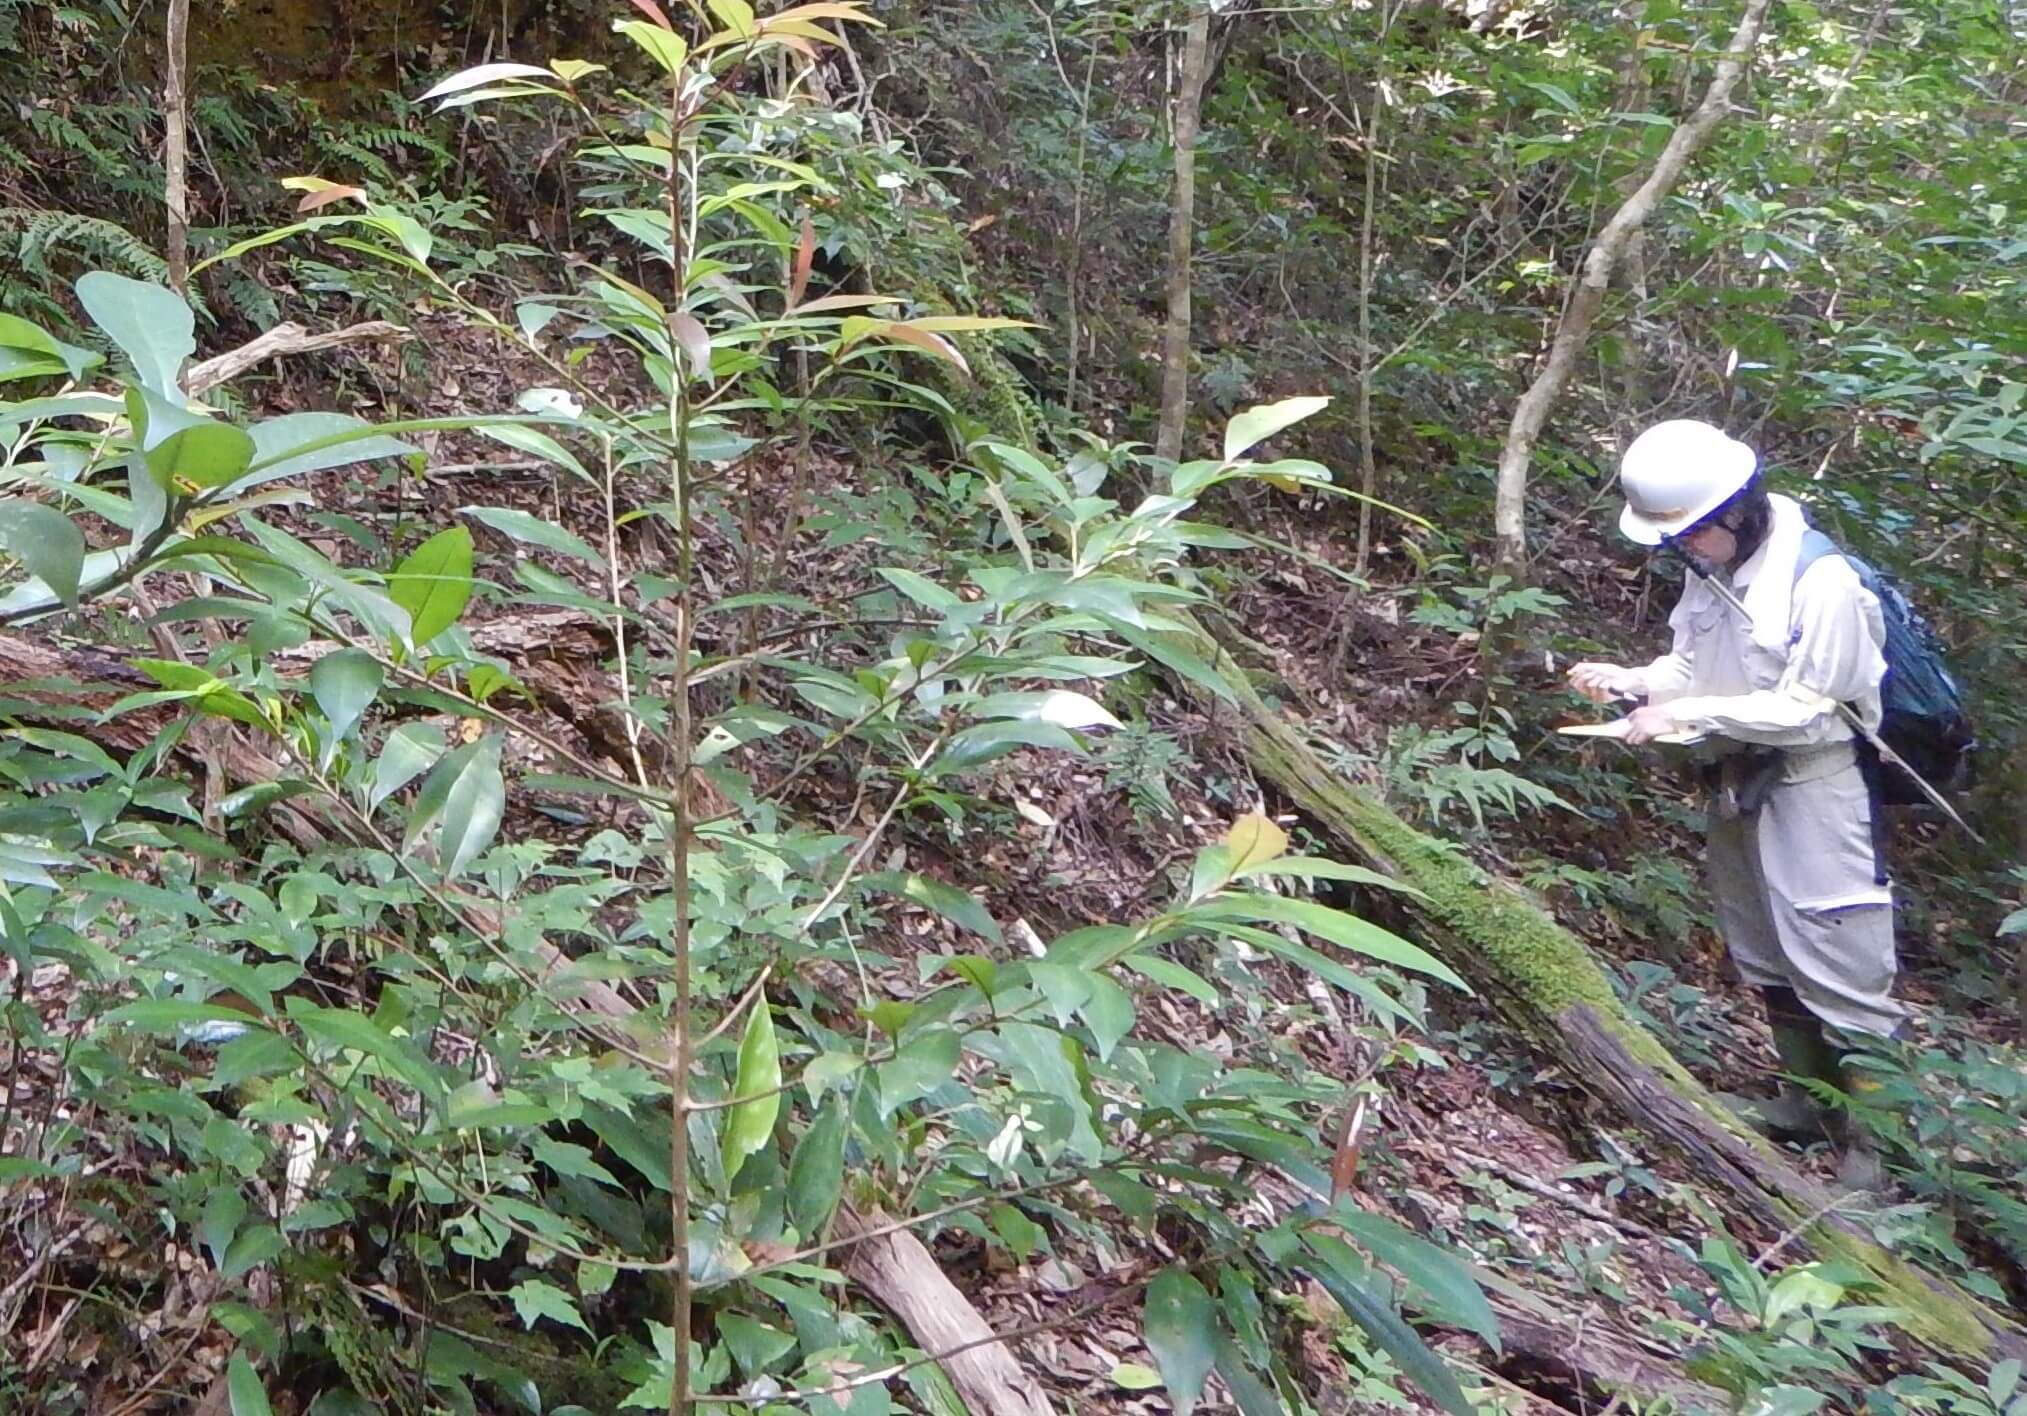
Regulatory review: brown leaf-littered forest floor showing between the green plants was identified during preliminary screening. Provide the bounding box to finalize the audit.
[0,328,2005,1412]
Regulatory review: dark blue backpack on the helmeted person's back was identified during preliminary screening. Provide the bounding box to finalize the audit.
[1794,529,1978,806]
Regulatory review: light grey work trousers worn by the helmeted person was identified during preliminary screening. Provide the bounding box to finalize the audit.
[1709,743,1905,1037]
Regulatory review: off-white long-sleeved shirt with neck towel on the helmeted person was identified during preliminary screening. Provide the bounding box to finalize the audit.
[1636,496,1887,748]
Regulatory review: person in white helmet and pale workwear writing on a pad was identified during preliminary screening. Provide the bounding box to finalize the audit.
[1569,419,1905,1187]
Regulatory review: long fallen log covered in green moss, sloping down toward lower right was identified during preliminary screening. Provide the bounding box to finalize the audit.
[1184,615,2027,1361]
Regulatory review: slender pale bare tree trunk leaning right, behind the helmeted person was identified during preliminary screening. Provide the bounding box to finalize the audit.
[1492,0,1772,581]
